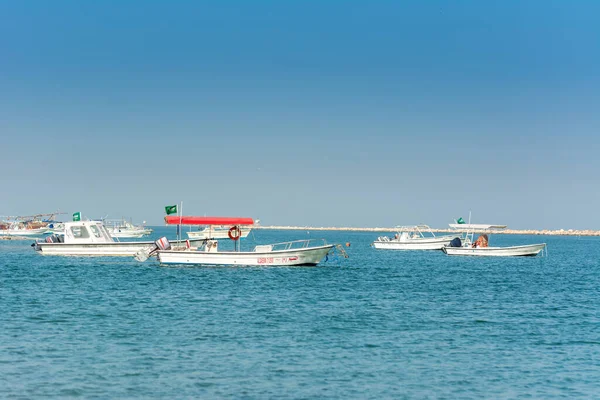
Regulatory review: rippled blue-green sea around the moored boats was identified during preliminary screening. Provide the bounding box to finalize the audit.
[0,227,600,399]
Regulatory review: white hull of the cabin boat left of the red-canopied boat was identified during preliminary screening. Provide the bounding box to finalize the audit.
[35,240,201,257]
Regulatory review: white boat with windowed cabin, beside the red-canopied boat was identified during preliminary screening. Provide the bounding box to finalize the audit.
[32,221,201,257]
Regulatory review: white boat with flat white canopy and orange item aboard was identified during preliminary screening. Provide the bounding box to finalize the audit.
[442,217,546,257]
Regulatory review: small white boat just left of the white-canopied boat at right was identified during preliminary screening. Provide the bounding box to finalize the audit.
[373,225,460,250]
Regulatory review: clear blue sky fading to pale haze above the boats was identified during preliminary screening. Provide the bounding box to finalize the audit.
[0,0,600,229]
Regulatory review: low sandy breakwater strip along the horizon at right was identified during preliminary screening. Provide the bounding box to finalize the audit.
[254,225,600,236]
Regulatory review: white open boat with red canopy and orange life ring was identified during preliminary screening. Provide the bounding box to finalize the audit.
[136,216,346,266]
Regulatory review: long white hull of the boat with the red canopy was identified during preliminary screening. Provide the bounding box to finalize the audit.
[158,245,334,266]
